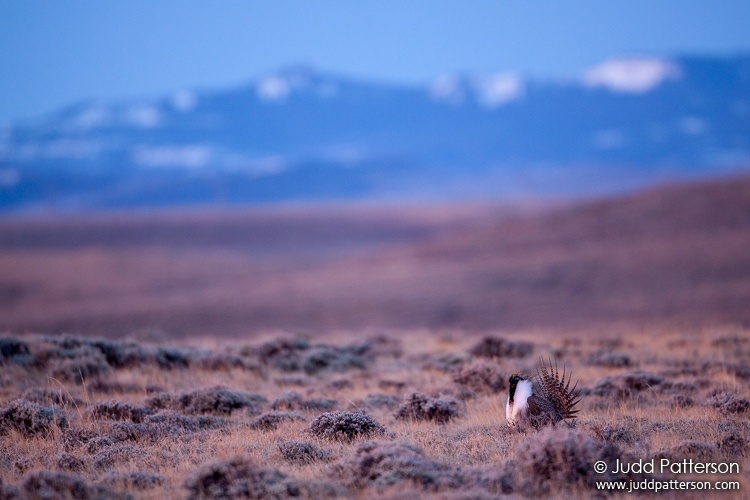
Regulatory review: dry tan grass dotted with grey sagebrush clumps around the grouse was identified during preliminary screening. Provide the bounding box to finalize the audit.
[0,329,750,498]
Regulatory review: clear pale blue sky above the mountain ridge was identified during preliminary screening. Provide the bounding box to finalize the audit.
[0,0,750,124]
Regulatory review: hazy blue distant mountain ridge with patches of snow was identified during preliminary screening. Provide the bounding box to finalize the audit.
[0,55,750,211]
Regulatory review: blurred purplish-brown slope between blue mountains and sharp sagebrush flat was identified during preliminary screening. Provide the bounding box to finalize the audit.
[0,177,750,337]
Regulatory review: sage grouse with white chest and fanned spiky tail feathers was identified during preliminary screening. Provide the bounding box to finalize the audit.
[505,359,580,428]
